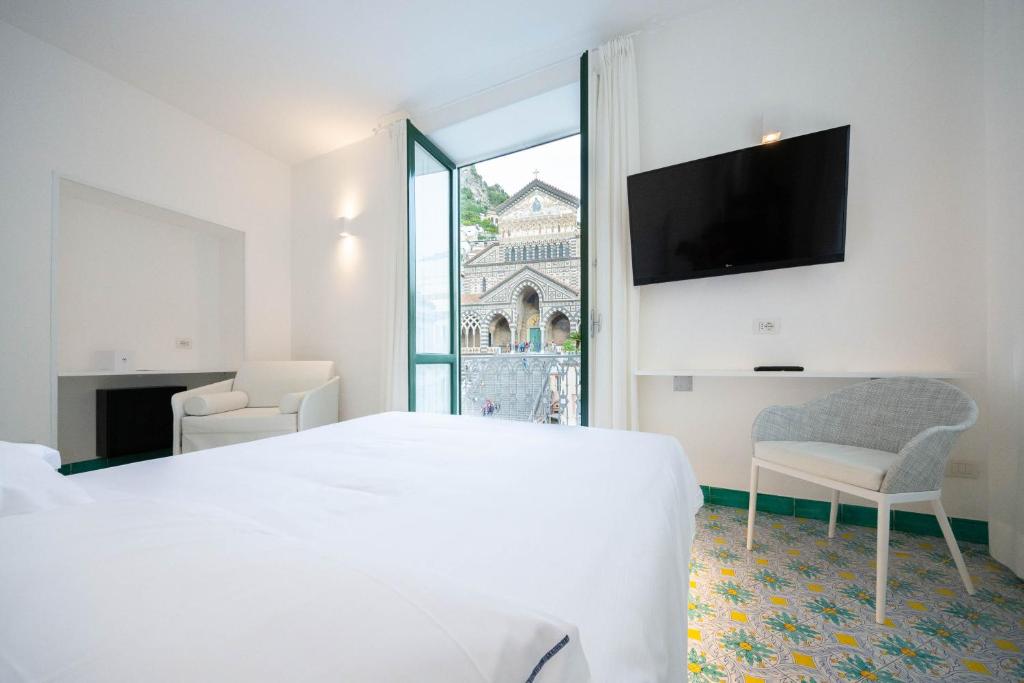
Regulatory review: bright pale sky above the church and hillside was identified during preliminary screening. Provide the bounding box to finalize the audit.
[468,135,580,197]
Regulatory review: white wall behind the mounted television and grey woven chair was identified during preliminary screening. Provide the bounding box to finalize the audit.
[636,0,986,519]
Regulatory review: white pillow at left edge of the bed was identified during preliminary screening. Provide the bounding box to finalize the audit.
[0,441,92,517]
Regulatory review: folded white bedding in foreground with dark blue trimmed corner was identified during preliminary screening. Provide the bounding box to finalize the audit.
[0,499,588,683]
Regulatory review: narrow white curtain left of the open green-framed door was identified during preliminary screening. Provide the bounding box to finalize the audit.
[377,119,409,411]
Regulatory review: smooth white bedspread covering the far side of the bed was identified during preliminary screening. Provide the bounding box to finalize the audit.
[68,413,702,683]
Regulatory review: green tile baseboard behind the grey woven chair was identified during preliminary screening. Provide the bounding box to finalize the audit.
[700,484,988,545]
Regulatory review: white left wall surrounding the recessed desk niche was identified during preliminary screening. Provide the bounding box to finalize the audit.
[0,18,291,443]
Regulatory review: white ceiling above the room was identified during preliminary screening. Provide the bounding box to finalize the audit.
[0,0,707,163]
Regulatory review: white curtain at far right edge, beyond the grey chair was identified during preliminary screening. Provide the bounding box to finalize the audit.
[985,0,1024,578]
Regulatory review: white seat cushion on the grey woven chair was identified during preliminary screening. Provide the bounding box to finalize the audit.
[754,441,899,490]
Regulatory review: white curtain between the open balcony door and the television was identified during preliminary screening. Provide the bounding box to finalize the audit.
[587,36,639,429]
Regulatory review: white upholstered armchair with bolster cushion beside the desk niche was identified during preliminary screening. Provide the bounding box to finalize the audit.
[171,360,340,455]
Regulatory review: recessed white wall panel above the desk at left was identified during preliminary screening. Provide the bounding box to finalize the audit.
[56,181,245,374]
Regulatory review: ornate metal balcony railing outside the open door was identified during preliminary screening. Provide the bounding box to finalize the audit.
[461,353,582,425]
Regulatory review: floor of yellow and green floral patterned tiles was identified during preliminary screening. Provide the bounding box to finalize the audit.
[687,506,1024,683]
